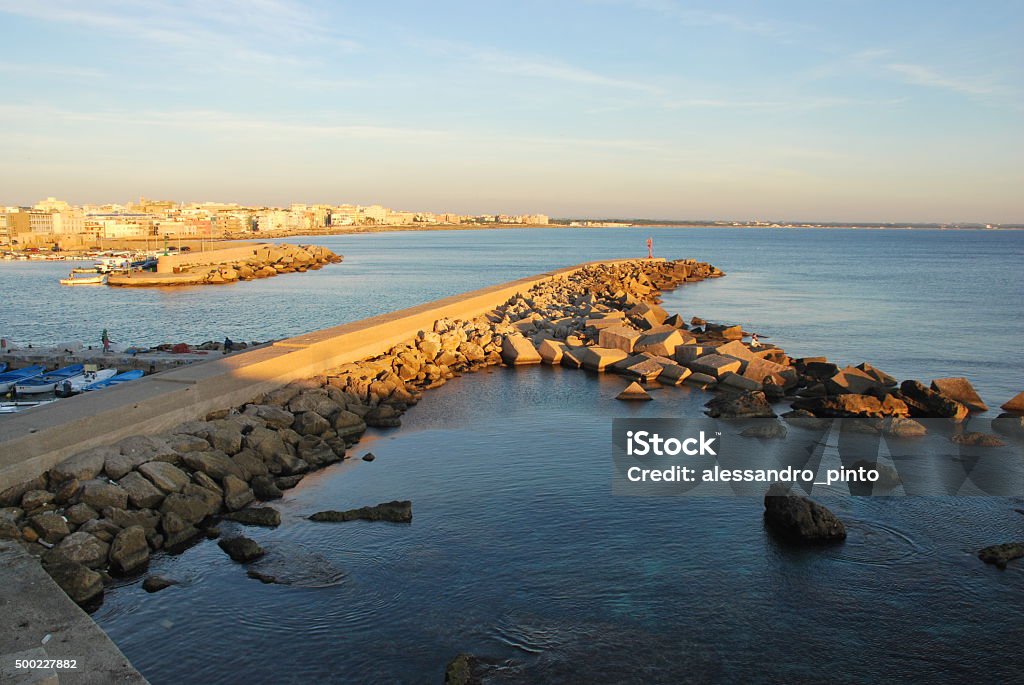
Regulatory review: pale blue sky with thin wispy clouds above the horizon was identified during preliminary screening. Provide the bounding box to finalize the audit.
[0,0,1024,223]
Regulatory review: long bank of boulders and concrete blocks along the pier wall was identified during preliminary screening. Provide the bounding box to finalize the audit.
[0,255,1019,601]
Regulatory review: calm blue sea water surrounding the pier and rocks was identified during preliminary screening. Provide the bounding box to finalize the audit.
[0,229,1024,685]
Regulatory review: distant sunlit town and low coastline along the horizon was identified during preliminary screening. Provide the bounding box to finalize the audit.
[0,198,1011,250]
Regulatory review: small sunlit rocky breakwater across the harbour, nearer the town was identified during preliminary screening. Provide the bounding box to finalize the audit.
[106,243,342,287]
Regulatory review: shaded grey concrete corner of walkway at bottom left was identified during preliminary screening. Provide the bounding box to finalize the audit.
[0,541,147,685]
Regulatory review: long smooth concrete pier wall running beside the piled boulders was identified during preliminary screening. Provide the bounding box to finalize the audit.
[0,259,655,491]
